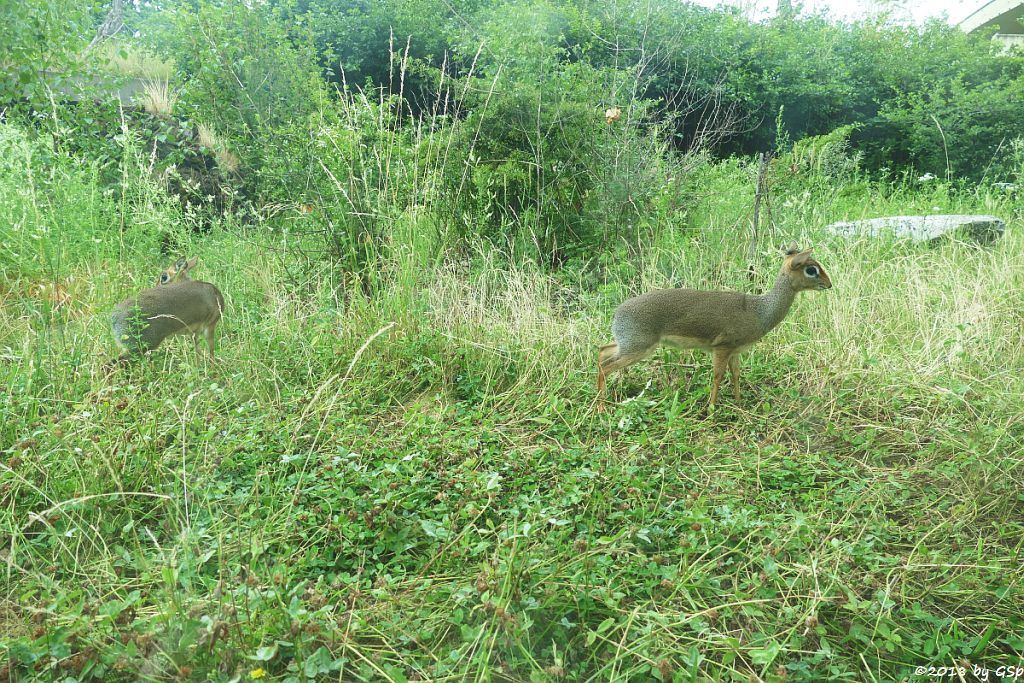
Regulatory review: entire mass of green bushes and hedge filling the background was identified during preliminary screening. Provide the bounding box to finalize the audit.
[74,0,1021,272]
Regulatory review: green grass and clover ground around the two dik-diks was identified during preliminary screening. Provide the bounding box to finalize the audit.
[0,143,1024,681]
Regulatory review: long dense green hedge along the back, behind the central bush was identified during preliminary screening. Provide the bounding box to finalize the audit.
[276,0,1024,179]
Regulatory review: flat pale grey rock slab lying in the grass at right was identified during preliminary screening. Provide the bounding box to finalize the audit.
[825,215,1007,243]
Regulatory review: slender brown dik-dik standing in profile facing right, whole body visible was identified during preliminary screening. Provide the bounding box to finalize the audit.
[597,244,831,411]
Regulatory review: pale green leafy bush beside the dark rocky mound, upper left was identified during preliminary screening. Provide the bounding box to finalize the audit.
[152,2,328,201]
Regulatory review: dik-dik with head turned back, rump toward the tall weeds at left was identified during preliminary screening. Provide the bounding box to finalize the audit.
[112,258,224,360]
